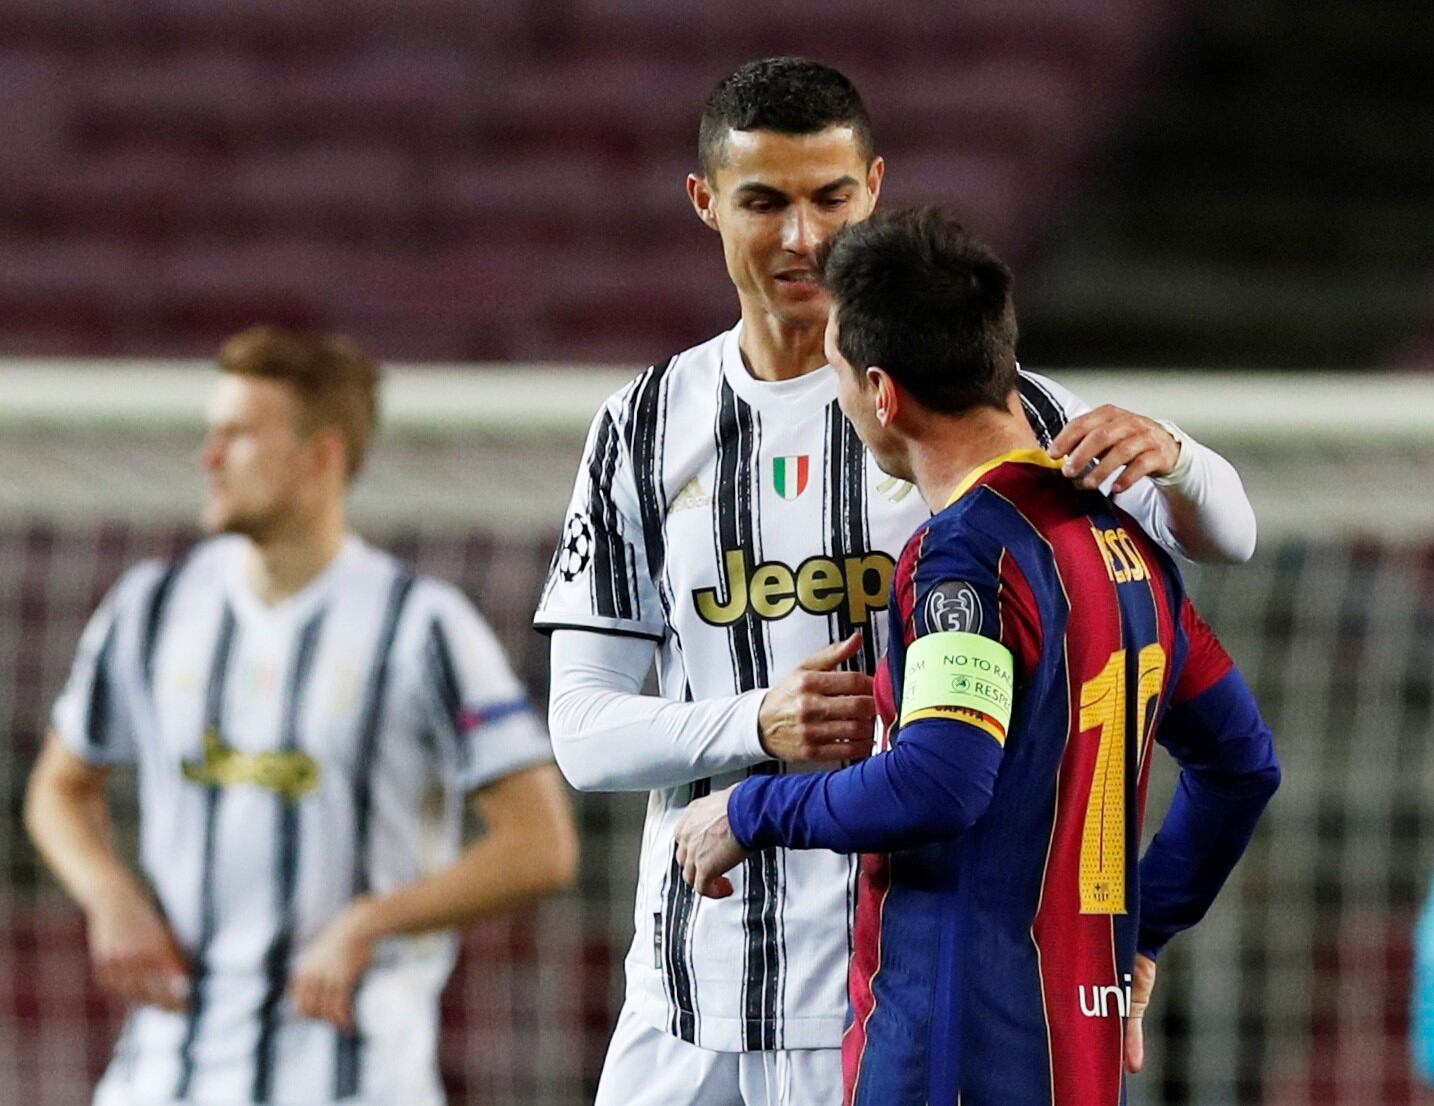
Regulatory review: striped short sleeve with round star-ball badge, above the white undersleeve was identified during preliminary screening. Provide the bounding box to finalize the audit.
[533,394,665,641]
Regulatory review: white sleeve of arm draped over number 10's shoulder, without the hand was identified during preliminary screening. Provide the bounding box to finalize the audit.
[1021,369,1255,564]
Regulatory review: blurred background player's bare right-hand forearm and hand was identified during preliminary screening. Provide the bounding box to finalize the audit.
[290,765,578,1030]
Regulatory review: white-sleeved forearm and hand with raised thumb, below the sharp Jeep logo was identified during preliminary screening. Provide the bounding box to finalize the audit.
[548,630,876,790]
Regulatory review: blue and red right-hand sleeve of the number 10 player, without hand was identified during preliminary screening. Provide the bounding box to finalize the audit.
[1136,605,1281,958]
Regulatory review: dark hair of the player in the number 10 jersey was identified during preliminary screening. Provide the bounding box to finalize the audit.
[817,208,1017,415]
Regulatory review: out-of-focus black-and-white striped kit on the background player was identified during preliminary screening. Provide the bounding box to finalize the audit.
[54,537,551,1106]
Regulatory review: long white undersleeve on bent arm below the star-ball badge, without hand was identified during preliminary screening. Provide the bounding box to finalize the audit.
[548,630,771,790]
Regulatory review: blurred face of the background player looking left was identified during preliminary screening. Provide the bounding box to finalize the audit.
[201,373,311,541]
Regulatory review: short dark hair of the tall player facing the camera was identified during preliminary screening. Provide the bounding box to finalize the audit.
[697,57,873,176]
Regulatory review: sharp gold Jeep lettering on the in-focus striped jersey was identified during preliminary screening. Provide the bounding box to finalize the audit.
[693,549,896,625]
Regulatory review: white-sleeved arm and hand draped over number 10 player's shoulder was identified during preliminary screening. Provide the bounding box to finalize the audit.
[1027,373,1256,564]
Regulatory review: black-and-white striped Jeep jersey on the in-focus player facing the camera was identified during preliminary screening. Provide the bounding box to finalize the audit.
[535,327,1243,1050]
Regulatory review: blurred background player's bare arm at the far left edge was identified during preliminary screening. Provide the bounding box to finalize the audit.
[24,733,189,1010]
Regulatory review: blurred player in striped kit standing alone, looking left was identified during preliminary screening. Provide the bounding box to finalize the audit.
[26,327,576,1106]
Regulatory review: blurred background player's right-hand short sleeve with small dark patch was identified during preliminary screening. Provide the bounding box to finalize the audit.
[414,580,552,792]
